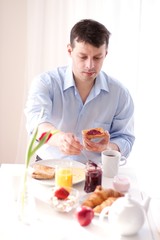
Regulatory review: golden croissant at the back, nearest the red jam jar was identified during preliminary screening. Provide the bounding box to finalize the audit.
[82,186,124,208]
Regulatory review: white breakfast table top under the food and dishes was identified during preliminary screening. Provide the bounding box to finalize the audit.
[0,164,160,240]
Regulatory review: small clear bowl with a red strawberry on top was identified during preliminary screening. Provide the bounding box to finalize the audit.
[50,187,79,212]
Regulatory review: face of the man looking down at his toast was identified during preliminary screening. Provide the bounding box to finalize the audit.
[68,41,107,82]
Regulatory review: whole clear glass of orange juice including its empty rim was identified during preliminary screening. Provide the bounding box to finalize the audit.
[55,162,73,187]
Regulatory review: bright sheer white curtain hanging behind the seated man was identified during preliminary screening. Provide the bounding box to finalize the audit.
[25,0,160,195]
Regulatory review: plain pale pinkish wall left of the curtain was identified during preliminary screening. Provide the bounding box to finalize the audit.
[0,0,27,163]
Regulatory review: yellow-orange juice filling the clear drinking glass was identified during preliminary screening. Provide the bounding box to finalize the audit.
[55,168,72,187]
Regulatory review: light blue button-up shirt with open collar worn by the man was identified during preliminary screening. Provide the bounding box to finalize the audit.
[25,66,135,163]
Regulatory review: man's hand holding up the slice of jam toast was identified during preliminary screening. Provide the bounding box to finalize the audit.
[83,131,110,152]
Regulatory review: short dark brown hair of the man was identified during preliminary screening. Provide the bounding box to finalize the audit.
[70,19,110,48]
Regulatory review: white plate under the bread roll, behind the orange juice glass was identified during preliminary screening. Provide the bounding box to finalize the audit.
[32,159,85,186]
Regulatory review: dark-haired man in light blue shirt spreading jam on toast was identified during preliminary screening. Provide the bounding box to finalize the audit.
[25,19,135,163]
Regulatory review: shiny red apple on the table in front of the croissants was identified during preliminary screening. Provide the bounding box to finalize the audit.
[76,206,94,226]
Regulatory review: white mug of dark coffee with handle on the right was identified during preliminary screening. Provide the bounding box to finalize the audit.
[101,150,127,178]
